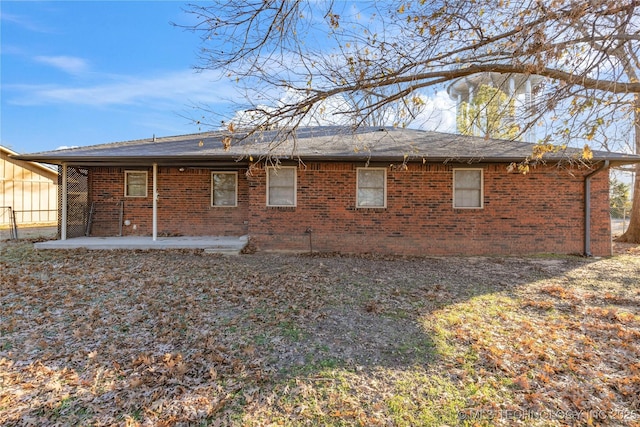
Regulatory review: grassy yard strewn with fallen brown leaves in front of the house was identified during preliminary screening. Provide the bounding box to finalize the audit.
[0,242,640,426]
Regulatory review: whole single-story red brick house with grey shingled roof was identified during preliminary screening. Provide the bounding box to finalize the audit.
[13,127,640,256]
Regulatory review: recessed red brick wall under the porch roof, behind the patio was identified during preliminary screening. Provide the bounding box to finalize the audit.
[90,167,248,236]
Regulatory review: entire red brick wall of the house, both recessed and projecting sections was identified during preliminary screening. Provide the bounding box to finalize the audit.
[85,162,611,255]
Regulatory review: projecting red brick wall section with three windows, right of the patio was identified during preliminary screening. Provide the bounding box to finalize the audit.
[249,163,611,255]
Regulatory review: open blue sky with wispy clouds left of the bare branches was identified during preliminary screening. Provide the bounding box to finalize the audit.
[0,0,234,153]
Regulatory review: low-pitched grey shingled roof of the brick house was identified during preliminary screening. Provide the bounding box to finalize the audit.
[11,127,640,166]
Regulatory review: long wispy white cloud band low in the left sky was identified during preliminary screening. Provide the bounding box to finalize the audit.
[6,70,233,108]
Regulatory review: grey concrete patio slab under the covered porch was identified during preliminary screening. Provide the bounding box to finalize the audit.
[34,236,249,255]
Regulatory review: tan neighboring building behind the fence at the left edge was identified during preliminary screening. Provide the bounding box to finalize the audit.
[0,145,58,226]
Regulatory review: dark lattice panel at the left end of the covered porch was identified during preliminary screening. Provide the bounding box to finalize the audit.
[58,166,89,241]
